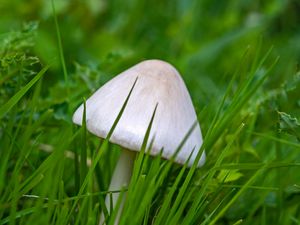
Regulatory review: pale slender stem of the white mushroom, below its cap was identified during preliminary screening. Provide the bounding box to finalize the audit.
[100,149,136,225]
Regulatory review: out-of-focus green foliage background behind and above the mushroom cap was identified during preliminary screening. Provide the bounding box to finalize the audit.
[0,0,300,125]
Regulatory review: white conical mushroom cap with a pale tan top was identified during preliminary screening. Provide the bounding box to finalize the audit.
[73,60,205,166]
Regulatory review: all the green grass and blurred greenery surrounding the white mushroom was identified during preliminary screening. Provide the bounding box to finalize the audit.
[0,0,300,225]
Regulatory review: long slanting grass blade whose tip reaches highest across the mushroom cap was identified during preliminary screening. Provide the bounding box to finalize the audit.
[67,77,138,221]
